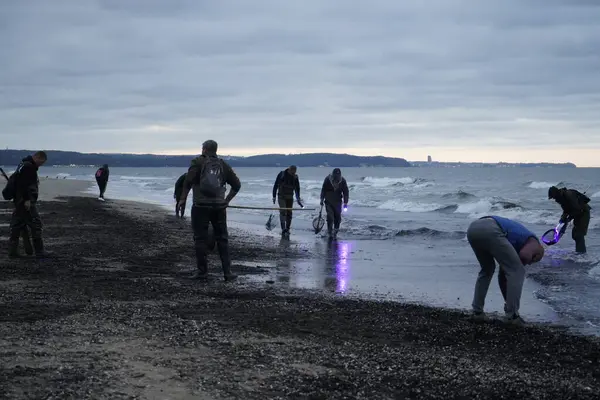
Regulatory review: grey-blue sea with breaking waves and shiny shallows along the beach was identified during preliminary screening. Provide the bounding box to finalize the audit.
[31,167,600,333]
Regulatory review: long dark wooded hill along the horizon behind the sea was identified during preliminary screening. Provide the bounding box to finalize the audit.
[0,150,411,168]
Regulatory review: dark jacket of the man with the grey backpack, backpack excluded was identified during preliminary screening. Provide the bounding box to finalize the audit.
[184,155,242,205]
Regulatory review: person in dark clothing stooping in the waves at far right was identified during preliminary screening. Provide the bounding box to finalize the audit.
[548,186,592,253]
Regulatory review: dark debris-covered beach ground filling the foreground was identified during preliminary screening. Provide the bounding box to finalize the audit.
[0,198,600,400]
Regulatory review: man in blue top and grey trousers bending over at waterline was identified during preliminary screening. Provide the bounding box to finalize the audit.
[467,216,544,323]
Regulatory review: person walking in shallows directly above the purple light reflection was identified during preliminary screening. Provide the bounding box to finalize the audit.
[321,168,349,239]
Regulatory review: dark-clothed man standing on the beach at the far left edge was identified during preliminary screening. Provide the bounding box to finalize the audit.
[8,151,51,258]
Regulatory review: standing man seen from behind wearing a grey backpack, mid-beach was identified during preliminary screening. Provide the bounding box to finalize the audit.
[179,140,242,281]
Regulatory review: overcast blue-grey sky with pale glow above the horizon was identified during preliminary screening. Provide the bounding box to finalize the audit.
[0,0,600,165]
